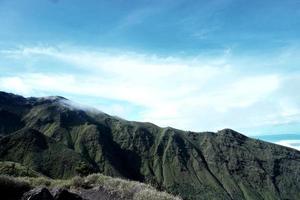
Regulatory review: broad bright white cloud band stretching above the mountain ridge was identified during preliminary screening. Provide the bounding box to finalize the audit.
[0,47,300,133]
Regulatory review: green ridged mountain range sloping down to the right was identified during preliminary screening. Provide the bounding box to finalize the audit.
[0,92,300,200]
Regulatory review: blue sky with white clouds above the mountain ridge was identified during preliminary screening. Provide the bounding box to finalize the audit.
[0,0,300,149]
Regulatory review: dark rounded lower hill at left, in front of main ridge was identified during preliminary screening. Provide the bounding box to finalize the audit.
[0,128,93,177]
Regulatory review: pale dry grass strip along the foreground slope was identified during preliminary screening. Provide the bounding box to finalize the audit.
[0,174,181,200]
